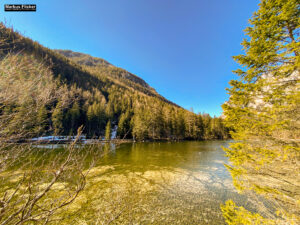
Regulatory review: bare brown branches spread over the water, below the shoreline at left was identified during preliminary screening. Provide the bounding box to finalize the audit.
[0,129,101,225]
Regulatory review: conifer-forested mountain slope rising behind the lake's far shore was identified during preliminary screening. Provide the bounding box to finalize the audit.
[0,24,229,140]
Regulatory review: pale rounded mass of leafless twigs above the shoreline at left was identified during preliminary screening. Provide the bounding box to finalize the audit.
[0,54,72,141]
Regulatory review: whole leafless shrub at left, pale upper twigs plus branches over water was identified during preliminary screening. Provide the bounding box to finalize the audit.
[0,47,105,225]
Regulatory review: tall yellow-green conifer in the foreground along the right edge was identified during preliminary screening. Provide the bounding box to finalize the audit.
[222,0,300,224]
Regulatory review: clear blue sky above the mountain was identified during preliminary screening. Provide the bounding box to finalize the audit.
[0,0,259,116]
